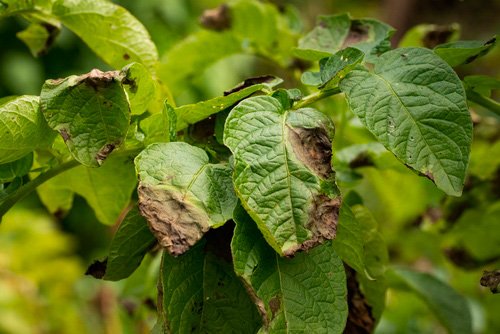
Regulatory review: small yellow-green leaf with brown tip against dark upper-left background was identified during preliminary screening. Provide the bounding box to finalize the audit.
[16,23,61,57]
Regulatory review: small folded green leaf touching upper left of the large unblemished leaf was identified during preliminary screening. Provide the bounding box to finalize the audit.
[302,48,365,88]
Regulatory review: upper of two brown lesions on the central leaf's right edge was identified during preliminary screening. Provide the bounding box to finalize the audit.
[288,127,333,179]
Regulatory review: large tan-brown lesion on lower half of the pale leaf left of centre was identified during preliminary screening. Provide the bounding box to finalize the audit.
[137,182,209,256]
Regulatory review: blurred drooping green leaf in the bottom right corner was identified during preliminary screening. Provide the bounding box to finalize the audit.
[391,268,472,334]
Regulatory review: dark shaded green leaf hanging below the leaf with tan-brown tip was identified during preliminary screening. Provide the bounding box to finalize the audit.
[160,236,260,333]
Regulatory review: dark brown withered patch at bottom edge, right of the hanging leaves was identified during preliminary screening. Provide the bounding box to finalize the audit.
[344,263,375,334]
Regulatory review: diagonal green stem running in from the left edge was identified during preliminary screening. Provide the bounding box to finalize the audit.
[0,160,80,219]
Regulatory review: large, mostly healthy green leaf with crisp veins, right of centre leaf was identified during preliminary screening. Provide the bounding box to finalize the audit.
[340,48,472,196]
